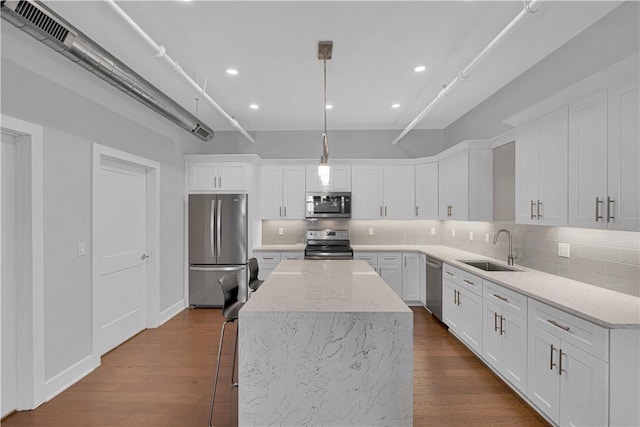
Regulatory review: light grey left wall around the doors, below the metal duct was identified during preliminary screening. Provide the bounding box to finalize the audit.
[1,38,192,380]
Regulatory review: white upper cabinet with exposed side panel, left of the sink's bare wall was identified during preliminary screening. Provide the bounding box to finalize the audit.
[438,149,493,221]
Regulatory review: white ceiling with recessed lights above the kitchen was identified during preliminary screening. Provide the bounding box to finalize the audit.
[45,0,620,137]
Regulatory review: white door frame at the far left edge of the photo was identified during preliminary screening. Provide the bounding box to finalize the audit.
[0,115,45,410]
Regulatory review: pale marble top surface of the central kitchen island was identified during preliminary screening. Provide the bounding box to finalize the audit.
[242,260,411,314]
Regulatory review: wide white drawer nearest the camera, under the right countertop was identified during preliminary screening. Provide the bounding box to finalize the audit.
[529,298,609,362]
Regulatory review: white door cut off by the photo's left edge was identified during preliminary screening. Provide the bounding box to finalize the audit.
[0,133,18,417]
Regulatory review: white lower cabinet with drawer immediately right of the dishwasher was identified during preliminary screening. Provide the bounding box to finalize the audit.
[442,264,482,354]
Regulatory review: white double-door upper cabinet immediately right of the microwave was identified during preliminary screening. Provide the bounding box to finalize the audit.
[351,165,415,219]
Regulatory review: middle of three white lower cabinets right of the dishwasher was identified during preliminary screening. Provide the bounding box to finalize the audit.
[482,280,527,393]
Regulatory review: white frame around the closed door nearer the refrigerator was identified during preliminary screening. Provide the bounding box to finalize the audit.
[91,143,160,355]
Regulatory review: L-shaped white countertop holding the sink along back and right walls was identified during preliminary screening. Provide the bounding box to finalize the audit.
[252,245,640,329]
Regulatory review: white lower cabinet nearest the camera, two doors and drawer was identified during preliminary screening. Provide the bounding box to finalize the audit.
[527,300,609,426]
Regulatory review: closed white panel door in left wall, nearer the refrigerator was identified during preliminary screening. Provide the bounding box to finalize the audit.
[94,159,147,355]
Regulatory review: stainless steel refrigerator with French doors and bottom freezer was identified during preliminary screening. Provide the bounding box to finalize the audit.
[189,194,248,307]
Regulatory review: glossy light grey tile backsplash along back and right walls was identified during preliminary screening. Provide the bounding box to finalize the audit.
[262,219,640,296]
